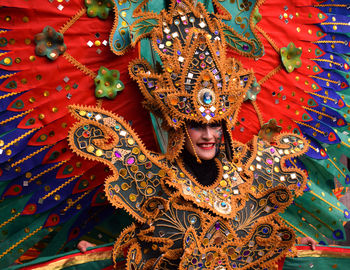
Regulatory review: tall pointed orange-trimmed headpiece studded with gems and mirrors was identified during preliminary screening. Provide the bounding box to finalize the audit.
[129,1,255,158]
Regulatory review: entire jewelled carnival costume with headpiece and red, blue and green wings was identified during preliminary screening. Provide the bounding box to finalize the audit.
[0,0,350,269]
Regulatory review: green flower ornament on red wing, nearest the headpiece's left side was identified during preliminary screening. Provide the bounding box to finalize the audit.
[95,67,124,99]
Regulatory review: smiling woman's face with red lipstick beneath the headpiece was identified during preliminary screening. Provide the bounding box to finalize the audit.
[185,123,222,160]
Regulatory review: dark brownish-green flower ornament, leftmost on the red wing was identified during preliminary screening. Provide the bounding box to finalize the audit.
[34,26,67,60]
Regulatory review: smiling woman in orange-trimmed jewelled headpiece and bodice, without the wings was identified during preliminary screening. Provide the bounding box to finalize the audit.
[69,1,314,269]
